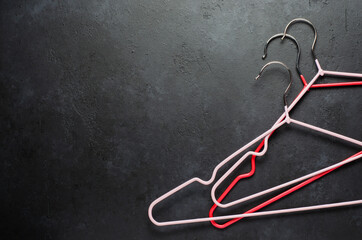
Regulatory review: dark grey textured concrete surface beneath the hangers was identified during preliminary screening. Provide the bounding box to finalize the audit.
[0,0,362,239]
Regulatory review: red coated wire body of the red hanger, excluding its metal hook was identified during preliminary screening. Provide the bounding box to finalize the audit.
[209,78,362,229]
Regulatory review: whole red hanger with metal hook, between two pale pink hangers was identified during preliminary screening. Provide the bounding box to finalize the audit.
[209,29,358,229]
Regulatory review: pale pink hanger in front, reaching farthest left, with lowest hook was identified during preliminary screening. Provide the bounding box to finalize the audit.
[148,63,362,226]
